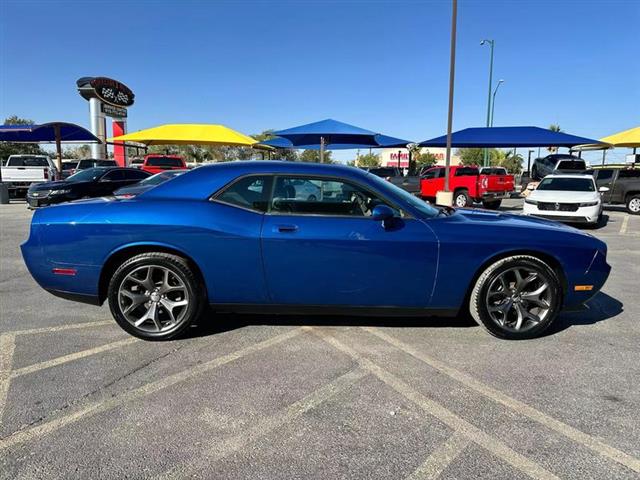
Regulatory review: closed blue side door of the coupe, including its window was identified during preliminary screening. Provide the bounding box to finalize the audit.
[262,175,437,307]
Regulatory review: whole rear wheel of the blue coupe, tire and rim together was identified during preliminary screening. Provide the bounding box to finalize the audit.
[108,252,205,340]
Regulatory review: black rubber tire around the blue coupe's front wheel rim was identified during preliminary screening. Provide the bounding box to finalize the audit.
[469,255,562,340]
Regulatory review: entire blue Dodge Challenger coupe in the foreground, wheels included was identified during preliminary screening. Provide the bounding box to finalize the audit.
[22,161,610,340]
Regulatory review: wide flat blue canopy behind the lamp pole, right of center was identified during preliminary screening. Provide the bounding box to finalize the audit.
[419,127,601,148]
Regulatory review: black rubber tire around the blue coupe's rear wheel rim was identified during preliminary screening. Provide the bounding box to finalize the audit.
[107,252,207,341]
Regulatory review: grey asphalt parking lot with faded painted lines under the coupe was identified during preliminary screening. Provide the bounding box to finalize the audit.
[0,200,640,479]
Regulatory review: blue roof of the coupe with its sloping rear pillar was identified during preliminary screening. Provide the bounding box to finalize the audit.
[141,160,373,199]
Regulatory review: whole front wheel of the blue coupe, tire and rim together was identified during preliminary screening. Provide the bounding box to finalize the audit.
[469,255,562,340]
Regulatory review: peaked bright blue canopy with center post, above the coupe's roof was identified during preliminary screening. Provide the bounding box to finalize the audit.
[270,119,409,162]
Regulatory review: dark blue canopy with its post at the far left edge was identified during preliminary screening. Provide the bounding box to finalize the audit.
[0,122,100,171]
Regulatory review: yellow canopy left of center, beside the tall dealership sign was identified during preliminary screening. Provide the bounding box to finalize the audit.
[107,124,258,147]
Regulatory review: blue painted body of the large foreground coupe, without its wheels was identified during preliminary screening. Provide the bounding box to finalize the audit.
[22,161,610,315]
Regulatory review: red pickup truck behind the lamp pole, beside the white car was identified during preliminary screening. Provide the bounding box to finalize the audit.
[420,165,514,208]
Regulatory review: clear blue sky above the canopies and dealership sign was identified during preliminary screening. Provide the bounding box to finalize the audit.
[0,0,640,163]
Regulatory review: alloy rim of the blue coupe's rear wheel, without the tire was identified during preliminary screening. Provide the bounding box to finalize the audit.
[118,265,189,333]
